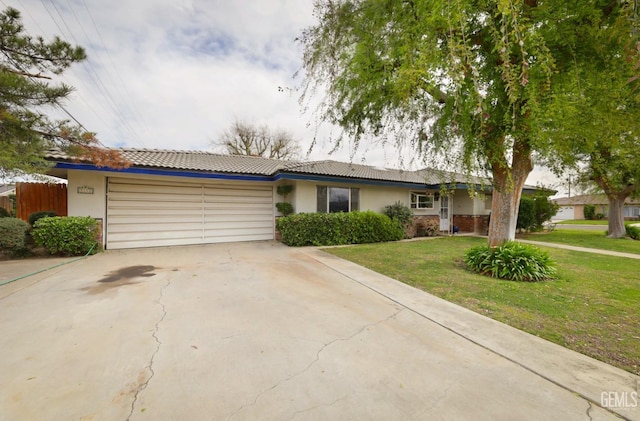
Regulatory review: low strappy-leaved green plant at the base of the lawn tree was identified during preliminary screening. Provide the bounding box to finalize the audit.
[464,241,556,282]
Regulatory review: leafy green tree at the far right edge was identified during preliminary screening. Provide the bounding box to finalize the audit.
[546,7,640,238]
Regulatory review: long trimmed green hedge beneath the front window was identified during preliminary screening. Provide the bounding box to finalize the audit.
[276,211,404,247]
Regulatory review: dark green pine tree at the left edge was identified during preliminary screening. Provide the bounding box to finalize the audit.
[0,7,126,177]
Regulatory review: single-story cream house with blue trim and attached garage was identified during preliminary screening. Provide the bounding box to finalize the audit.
[47,149,535,249]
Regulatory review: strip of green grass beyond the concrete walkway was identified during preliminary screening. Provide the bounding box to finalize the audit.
[518,229,640,254]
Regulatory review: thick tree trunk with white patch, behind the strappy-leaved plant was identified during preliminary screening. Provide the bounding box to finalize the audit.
[489,140,533,247]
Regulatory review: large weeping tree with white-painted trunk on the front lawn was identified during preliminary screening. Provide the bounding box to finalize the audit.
[300,0,631,246]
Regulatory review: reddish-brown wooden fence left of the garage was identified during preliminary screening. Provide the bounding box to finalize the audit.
[16,183,67,222]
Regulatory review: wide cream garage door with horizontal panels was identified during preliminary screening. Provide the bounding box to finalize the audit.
[106,178,274,249]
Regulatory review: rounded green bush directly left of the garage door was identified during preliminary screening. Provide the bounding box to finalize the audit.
[31,216,98,256]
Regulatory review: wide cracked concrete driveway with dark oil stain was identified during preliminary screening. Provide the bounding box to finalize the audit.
[0,242,640,420]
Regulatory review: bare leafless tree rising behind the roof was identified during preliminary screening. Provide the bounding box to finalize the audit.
[214,120,300,159]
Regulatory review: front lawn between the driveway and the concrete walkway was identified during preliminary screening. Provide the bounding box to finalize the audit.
[325,237,640,374]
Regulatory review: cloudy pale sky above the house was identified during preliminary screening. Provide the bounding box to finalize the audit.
[5,0,559,194]
